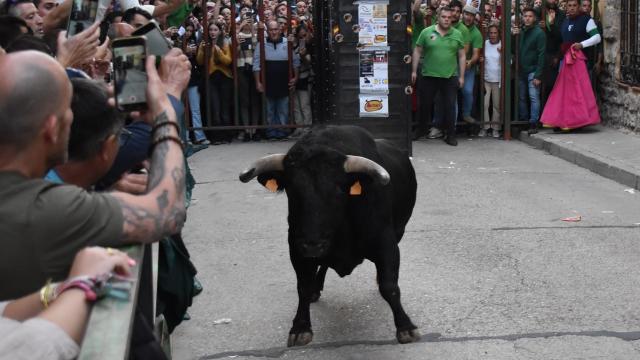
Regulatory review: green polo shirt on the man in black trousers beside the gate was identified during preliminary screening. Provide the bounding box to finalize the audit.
[416,25,464,78]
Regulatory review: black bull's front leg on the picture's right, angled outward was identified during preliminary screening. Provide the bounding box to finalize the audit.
[374,241,420,344]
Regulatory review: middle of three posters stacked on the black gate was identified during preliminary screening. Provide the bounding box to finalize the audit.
[360,47,389,94]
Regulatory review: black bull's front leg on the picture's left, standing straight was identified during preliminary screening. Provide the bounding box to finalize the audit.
[287,256,318,347]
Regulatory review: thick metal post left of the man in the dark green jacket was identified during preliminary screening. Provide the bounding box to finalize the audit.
[502,0,513,140]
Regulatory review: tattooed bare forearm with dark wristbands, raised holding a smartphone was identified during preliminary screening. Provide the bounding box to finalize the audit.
[112,53,190,243]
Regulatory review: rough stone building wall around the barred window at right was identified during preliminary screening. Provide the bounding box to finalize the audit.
[597,0,640,133]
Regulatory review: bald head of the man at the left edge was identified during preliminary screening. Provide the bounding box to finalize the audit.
[0,51,73,150]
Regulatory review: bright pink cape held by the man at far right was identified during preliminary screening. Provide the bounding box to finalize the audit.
[540,48,600,129]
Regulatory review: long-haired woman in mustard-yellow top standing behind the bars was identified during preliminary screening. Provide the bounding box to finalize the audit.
[196,22,233,145]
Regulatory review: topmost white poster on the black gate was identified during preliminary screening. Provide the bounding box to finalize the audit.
[358,1,387,46]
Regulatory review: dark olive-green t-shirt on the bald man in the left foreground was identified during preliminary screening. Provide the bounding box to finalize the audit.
[0,171,124,300]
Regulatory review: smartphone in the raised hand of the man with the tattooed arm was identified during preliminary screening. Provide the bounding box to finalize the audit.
[113,36,147,112]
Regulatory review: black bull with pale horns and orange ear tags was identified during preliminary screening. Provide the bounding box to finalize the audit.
[240,126,420,346]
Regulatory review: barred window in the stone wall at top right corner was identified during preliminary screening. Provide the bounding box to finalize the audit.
[620,0,640,86]
